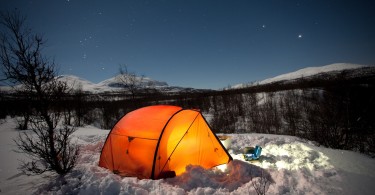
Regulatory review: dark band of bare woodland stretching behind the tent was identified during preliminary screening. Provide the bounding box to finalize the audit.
[0,75,375,156]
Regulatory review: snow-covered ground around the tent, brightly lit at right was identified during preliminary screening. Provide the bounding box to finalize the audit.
[0,118,375,195]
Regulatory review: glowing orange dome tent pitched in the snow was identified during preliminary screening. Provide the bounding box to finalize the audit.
[99,105,232,179]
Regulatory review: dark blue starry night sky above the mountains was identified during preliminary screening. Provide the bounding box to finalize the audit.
[0,0,375,89]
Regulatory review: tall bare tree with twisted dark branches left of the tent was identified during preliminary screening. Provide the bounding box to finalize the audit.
[0,11,78,174]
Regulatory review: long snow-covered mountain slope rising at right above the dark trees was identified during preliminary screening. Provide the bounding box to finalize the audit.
[231,63,375,89]
